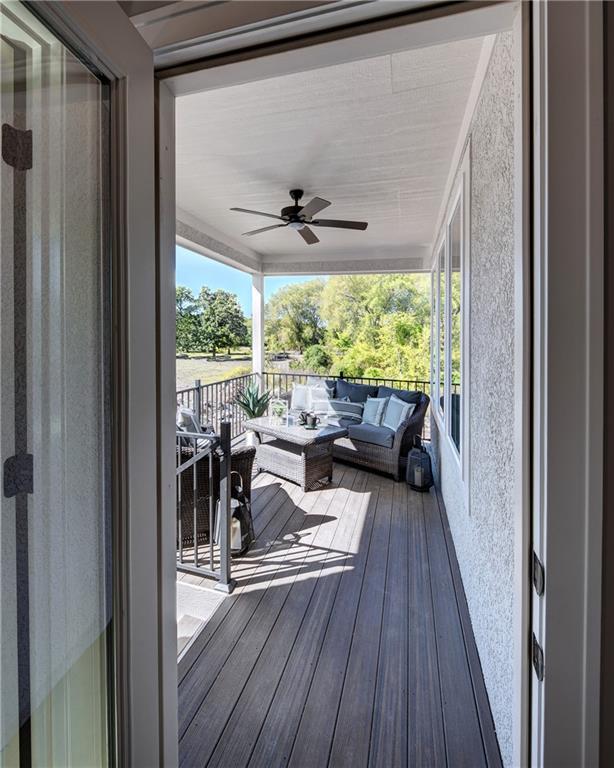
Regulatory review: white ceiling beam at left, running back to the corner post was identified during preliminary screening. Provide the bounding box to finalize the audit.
[176,209,262,272]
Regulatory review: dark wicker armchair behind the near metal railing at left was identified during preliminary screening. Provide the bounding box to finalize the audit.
[177,445,256,549]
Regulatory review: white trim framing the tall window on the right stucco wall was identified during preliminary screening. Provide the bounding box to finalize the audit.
[431,146,471,513]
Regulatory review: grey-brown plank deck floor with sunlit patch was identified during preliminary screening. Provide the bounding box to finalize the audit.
[179,465,500,768]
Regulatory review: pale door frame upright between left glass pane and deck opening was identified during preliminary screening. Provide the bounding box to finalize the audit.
[31,0,177,768]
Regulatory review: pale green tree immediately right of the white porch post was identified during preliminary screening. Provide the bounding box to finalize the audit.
[265,278,325,352]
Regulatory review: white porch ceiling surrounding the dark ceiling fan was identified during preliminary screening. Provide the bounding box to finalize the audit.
[176,38,483,270]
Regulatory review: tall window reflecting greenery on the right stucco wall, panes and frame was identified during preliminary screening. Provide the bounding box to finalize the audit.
[431,150,470,479]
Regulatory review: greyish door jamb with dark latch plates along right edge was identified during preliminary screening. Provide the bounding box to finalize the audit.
[531,2,604,766]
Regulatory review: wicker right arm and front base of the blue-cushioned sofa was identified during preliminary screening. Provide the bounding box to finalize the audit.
[333,394,430,480]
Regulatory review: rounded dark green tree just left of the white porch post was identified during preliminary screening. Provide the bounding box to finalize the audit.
[198,286,247,358]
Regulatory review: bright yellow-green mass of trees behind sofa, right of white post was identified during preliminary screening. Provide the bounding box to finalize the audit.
[265,274,431,379]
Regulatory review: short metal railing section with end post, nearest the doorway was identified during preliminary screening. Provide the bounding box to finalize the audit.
[175,421,234,592]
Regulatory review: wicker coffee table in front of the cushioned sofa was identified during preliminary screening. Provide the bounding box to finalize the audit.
[245,416,347,491]
